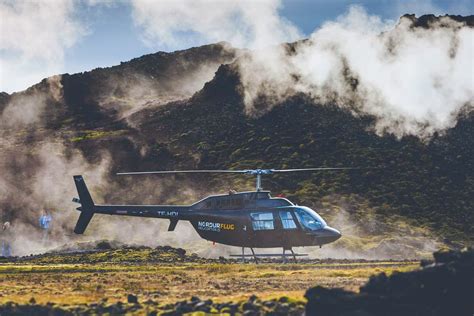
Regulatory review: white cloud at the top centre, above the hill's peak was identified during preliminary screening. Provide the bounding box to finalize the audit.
[131,0,300,50]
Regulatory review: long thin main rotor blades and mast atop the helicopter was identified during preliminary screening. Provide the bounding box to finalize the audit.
[117,167,360,192]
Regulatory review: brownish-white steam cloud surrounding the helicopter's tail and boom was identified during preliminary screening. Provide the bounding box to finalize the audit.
[0,75,228,256]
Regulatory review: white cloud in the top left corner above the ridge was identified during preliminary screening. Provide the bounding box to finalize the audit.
[0,0,85,92]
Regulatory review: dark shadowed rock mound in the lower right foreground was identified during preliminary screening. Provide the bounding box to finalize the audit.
[305,249,474,316]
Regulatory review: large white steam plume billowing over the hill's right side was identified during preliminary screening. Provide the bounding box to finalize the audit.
[240,7,474,138]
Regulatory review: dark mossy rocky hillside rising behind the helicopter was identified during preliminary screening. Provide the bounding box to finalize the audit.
[0,16,474,251]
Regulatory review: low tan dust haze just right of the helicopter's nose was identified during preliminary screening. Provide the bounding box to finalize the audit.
[308,203,443,260]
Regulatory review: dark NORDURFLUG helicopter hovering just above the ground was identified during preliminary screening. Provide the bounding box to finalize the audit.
[73,167,348,263]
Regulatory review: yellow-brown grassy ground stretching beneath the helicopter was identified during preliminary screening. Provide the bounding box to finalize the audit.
[0,247,419,313]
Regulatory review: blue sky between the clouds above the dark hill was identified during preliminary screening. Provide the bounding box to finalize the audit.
[0,0,474,92]
